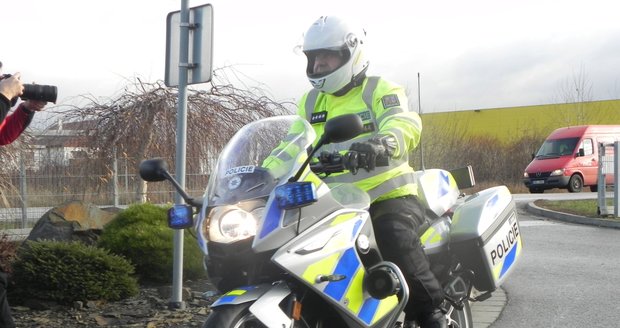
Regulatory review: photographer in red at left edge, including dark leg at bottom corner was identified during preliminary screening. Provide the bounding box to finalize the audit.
[0,62,47,328]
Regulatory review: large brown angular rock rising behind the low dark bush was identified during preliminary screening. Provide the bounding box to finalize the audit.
[26,201,118,245]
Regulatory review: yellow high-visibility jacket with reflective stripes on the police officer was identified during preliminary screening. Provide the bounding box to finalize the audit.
[297,77,422,201]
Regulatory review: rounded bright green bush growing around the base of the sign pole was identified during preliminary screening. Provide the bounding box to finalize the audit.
[98,204,204,282]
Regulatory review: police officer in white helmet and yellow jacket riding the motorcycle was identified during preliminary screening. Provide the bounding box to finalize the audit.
[297,16,446,328]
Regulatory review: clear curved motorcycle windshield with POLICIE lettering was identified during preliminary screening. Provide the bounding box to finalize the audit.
[206,115,316,206]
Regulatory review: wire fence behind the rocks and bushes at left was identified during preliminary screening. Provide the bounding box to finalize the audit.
[0,157,208,232]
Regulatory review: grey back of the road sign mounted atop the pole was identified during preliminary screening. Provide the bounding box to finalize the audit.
[165,4,213,87]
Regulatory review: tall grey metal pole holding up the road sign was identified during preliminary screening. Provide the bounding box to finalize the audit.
[168,0,189,309]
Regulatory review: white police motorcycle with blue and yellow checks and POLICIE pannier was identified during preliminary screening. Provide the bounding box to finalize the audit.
[140,114,522,328]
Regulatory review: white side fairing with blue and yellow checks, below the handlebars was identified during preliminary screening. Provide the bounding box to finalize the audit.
[272,210,399,327]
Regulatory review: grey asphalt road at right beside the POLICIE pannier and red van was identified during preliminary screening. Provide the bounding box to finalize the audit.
[472,193,620,328]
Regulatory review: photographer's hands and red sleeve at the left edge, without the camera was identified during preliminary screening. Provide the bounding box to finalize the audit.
[0,62,47,146]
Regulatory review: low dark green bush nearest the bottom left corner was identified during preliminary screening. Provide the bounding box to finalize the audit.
[12,241,138,304]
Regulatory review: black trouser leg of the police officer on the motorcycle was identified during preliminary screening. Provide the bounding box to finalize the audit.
[370,196,444,318]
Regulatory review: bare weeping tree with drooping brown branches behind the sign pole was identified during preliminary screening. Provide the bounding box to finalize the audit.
[0,67,294,207]
